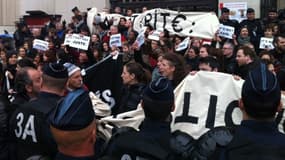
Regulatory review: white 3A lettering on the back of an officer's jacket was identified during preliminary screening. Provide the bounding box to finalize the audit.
[14,112,37,143]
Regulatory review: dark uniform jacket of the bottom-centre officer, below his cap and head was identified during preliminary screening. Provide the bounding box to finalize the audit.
[104,119,172,160]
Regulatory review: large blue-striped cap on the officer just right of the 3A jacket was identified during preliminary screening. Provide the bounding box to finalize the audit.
[50,89,95,131]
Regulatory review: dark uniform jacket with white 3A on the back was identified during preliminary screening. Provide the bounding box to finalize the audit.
[10,92,61,160]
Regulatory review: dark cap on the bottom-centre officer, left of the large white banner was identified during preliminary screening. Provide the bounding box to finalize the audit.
[144,77,174,101]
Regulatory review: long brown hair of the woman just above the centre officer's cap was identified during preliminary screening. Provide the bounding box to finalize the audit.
[162,53,186,87]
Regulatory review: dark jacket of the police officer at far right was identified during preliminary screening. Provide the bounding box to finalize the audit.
[209,120,285,160]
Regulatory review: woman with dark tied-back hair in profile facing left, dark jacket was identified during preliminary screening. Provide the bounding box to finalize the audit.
[116,62,150,114]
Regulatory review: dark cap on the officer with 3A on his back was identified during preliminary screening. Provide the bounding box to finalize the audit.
[43,63,68,79]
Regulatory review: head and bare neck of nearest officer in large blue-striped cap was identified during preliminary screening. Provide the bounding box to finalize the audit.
[50,89,96,160]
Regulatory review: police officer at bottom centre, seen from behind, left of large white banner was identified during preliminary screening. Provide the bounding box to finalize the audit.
[103,77,174,160]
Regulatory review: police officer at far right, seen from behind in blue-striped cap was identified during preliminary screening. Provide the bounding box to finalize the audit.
[193,63,285,160]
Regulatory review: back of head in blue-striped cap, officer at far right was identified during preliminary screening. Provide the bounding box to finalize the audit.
[242,63,281,118]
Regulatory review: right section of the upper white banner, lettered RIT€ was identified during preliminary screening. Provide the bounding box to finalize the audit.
[134,8,220,39]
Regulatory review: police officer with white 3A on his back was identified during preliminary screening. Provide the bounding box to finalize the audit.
[10,63,68,160]
